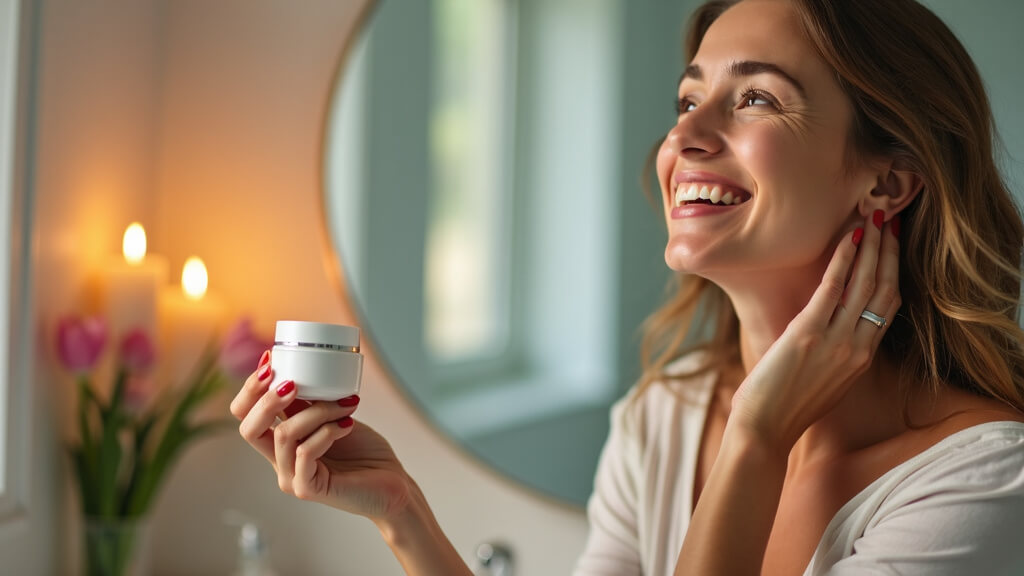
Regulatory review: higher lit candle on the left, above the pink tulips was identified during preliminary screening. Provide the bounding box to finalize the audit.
[103,222,167,341]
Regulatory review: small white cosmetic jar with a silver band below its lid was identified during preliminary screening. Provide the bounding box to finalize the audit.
[270,320,362,401]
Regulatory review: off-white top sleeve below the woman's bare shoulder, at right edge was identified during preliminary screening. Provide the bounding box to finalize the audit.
[815,423,1024,576]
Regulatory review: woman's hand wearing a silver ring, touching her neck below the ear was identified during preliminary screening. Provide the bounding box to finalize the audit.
[729,210,900,454]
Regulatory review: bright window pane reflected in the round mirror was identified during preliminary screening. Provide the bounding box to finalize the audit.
[424,0,515,365]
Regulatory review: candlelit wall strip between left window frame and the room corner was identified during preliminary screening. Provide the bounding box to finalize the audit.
[14,0,160,575]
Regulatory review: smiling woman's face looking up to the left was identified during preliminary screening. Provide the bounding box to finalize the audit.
[657,0,876,281]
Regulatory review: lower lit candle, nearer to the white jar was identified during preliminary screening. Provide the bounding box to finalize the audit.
[161,256,224,383]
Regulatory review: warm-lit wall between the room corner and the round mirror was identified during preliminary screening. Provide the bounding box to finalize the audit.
[154,0,586,576]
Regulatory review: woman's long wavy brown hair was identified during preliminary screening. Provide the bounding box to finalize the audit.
[639,0,1024,411]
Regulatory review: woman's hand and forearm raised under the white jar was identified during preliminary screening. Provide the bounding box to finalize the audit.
[231,353,470,576]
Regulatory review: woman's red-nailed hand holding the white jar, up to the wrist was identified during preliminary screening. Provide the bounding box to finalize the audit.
[230,353,411,522]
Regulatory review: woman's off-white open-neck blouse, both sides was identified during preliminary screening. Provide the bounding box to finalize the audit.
[574,356,1024,576]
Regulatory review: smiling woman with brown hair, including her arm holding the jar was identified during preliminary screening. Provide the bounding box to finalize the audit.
[231,0,1024,576]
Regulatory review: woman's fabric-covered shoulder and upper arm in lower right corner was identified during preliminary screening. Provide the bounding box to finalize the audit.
[807,420,1024,575]
